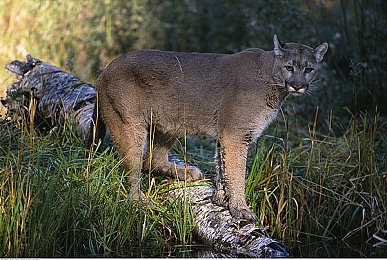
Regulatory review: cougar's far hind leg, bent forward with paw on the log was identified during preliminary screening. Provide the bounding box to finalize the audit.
[144,130,203,181]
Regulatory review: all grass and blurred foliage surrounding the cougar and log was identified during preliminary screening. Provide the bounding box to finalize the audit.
[0,0,387,256]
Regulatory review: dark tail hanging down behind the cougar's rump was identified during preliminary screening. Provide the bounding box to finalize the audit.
[86,93,106,149]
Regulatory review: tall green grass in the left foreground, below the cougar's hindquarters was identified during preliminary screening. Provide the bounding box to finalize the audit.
[0,119,197,257]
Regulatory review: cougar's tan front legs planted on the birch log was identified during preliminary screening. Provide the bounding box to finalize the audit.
[213,137,257,221]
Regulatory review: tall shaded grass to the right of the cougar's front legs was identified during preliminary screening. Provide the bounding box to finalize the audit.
[246,106,387,242]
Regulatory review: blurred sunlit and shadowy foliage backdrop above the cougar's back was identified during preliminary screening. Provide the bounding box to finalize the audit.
[0,0,387,120]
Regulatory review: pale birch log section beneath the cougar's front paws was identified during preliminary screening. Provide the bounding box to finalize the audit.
[168,185,288,257]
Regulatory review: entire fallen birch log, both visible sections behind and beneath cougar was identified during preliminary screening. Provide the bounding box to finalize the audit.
[1,55,289,257]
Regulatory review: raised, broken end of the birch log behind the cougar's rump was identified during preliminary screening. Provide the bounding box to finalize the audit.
[1,55,96,140]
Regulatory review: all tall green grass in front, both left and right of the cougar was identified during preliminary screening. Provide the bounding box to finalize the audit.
[0,104,387,257]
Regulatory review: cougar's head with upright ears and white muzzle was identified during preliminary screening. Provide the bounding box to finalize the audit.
[273,35,328,96]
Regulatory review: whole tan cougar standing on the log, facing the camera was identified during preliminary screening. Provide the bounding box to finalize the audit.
[88,35,328,221]
